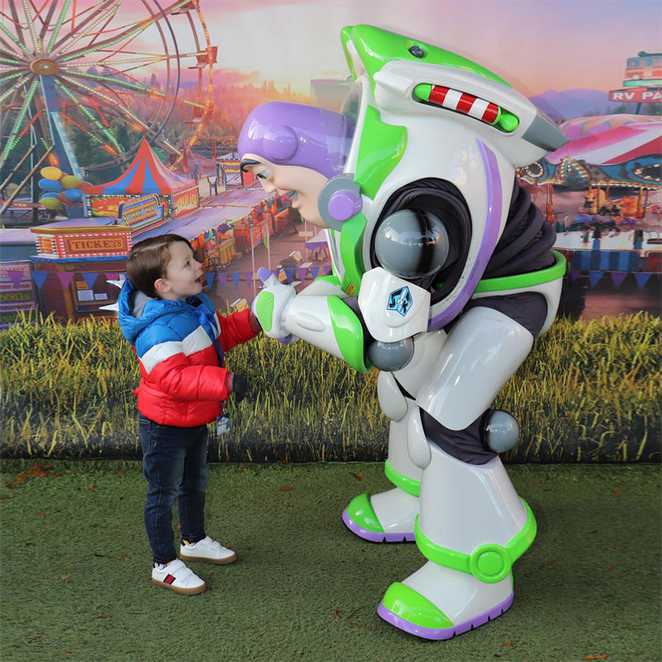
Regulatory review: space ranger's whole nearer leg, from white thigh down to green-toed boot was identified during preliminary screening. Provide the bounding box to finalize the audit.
[378,307,536,639]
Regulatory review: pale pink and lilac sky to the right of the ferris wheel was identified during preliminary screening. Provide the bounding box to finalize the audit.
[191,0,662,95]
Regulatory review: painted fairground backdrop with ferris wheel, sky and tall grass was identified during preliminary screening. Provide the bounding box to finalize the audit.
[0,0,662,462]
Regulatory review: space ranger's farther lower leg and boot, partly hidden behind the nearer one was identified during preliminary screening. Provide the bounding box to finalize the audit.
[342,372,422,542]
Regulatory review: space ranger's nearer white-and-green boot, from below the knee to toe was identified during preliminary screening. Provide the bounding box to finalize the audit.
[377,445,536,639]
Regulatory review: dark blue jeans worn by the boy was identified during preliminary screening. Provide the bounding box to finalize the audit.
[138,415,209,563]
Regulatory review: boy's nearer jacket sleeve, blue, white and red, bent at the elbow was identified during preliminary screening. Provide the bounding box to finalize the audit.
[136,325,230,400]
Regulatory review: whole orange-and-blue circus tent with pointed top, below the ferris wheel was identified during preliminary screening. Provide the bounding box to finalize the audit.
[84,138,200,216]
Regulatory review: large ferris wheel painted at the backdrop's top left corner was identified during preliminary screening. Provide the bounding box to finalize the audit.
[0,0,217,186]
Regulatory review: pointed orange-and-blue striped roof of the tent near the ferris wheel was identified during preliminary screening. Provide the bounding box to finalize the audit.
[85,138,197,195]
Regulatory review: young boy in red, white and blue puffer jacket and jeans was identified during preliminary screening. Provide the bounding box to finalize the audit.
[119,234,260,594]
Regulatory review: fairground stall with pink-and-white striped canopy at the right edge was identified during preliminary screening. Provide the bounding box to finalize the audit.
[522,114,662,288]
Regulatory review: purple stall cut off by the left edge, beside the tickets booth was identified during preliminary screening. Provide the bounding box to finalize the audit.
[0,229,37,329]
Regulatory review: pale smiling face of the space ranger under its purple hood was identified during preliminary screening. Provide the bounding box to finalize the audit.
[244,154,329,228]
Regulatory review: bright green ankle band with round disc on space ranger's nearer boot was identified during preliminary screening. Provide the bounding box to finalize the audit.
[415,499,538,584]
